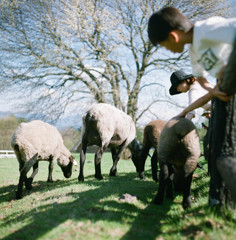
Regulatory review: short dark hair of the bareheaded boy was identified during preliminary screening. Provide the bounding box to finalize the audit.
[148,7,193,46]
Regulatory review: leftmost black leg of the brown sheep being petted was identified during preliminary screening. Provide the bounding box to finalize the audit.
[154,163,169,204]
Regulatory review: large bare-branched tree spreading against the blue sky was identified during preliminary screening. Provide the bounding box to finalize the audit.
[0,0,228,121]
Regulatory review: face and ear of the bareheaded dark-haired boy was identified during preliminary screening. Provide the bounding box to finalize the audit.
[160,32,184,53]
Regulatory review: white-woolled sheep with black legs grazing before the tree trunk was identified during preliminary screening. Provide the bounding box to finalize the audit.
[78,103,141,181]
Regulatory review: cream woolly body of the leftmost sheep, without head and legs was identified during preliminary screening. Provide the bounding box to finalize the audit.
[11,120,63,159]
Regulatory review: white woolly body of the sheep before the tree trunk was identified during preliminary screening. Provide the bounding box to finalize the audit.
[82,103,136,147]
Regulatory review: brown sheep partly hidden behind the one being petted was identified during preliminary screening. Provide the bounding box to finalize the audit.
[139,120,166,182]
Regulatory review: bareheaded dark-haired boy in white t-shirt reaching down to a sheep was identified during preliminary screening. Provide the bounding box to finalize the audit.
[148,7,236,205]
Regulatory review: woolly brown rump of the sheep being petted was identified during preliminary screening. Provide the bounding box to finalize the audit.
[158,118,201,174]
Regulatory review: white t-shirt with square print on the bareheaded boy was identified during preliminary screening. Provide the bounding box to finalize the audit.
[189,17,236,78]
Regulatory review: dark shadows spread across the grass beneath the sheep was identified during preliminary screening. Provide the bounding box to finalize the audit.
[0,164,225,240]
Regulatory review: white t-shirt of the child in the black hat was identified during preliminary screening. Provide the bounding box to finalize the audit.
[188,81,211,115]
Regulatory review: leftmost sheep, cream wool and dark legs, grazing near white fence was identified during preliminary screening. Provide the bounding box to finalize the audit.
[11,120,76,199]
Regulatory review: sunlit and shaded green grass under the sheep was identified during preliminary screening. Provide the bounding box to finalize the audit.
[0,153,236,240]
